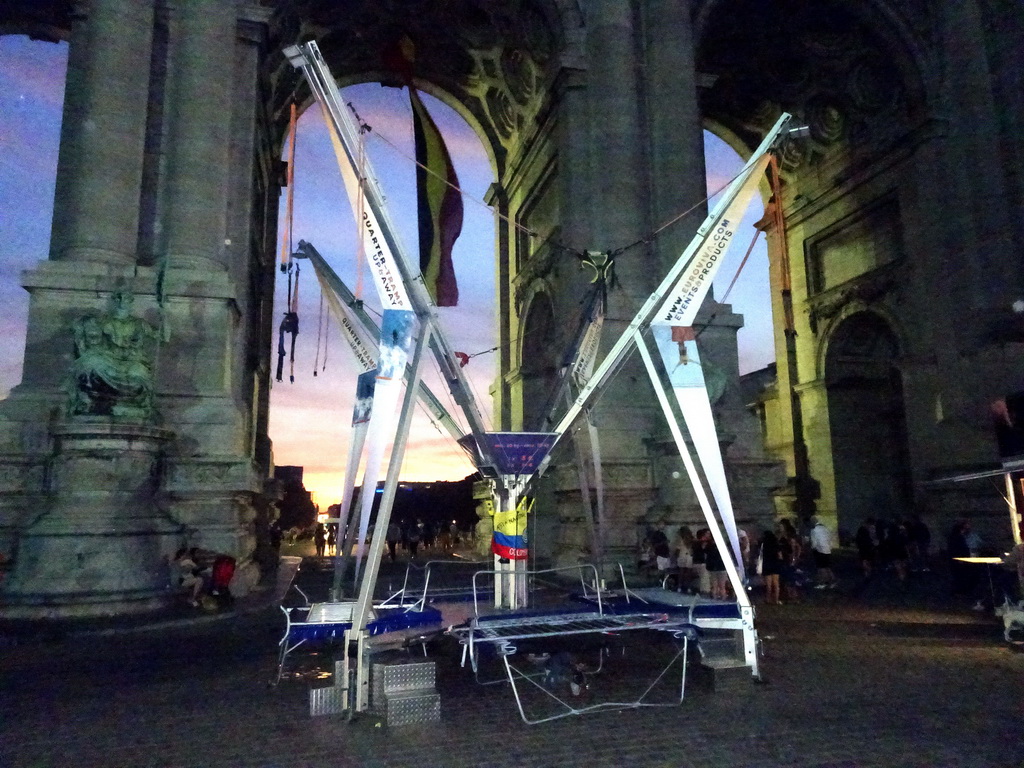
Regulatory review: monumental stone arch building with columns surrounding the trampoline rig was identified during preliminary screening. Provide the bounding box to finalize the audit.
[0,0,1024,615]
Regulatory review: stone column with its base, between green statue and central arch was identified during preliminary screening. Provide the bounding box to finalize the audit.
[151,0,273,596]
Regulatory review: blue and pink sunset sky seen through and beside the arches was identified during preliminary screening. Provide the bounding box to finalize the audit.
[0,36,774,505]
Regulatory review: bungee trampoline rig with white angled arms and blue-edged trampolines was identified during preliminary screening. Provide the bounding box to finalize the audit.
[278,42,802,724]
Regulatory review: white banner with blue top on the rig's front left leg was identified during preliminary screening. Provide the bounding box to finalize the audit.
[355,309,416,579]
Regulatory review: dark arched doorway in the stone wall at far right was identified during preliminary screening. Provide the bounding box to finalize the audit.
[824,311,911,532]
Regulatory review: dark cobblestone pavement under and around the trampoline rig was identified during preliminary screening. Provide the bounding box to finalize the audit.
[0,552,1024,768]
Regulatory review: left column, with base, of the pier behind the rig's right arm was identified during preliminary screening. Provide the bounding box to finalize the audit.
[550,0,659,565]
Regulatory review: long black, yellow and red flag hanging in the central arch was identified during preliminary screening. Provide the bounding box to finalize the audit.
[409,86,463,306]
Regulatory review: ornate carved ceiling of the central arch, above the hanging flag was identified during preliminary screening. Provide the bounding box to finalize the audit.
[268,0,577,174]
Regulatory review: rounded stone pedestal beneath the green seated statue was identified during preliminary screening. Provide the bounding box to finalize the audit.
[2,418,184,618]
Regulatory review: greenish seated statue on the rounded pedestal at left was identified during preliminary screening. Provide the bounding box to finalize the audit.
[68,291,157,422]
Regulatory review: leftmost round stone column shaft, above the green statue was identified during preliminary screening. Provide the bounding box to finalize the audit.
[50,0,154,265]
